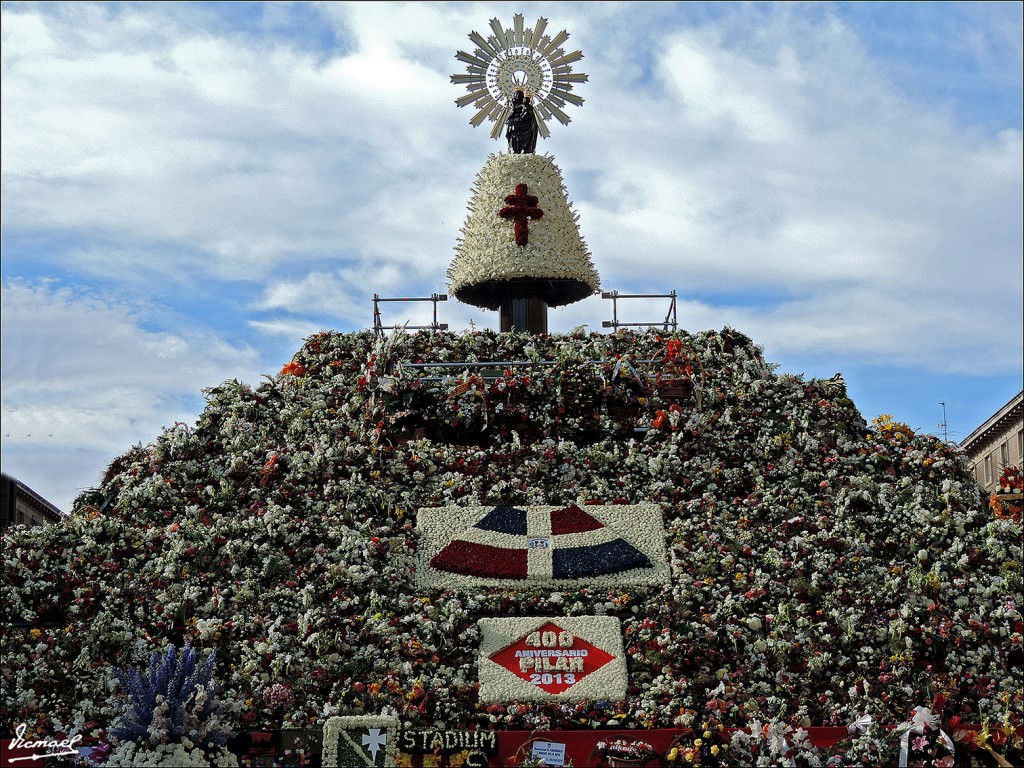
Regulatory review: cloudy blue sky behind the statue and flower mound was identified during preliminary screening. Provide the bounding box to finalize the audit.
[0,2,1024,518]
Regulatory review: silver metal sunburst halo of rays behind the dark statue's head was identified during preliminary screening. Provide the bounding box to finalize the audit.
[452,13,587,138]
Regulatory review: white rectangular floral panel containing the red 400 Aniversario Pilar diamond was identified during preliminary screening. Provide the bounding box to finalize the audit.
[479,616,627,703]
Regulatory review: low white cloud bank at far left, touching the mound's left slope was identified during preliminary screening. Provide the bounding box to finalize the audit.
[2,280,261,507]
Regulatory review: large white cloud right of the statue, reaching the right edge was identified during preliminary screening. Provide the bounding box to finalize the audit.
[540,6,1022,371]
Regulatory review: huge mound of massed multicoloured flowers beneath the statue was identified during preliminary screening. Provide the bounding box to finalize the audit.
[0,329,1024,753]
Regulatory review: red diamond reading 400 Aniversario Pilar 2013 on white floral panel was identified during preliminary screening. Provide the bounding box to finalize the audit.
[489,622,615,694]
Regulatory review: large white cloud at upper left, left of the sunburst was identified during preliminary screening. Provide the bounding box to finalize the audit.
[3,6,466,279]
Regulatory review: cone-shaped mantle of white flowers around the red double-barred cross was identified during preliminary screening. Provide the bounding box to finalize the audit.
[447,154,600,303]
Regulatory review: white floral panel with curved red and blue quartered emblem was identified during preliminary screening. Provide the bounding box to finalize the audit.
[417,504,669,589]
